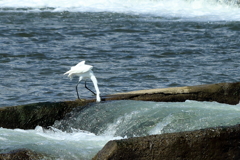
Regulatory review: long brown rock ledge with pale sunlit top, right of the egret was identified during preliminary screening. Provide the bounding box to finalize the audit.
[106,82,240,104]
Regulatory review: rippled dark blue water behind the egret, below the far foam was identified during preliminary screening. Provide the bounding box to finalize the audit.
[0,10,240,107]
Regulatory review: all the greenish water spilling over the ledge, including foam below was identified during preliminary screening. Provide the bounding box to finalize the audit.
[0,101,240,160]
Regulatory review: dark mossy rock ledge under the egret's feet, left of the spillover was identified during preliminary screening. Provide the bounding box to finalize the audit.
[0,100,93,129]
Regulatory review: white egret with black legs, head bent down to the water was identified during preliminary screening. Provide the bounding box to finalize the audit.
[64,61,101,102]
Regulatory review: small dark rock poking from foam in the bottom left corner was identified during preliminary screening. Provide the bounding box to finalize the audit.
[0,149,46,160]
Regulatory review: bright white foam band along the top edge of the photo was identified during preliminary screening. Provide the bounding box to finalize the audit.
[0,0,240,21]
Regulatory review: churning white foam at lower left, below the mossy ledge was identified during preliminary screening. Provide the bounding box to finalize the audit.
[0,126,121,159]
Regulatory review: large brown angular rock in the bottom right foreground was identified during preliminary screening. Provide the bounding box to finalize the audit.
[93,125,240,160]
